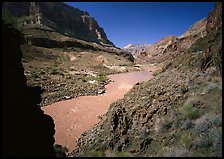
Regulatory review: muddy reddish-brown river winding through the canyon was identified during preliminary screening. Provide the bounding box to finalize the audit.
[41,65,155,151]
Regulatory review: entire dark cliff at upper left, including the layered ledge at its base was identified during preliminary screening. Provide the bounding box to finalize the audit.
[2,2,134,62]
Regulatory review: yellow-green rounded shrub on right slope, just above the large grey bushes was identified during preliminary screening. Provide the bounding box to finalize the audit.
[179,104,198,119]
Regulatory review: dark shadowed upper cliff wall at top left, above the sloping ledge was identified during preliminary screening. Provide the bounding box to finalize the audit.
[3,2,114,46]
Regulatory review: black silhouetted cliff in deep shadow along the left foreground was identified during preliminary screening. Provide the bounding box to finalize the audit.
[2,21,55,156]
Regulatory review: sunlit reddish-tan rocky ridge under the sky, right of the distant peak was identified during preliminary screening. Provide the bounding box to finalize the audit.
[146,18,207,66]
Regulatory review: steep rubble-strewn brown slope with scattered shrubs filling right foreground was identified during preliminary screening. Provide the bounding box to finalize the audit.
[70,3,222,157]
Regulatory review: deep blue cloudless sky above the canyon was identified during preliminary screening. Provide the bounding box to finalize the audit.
[65,2,215,48]
